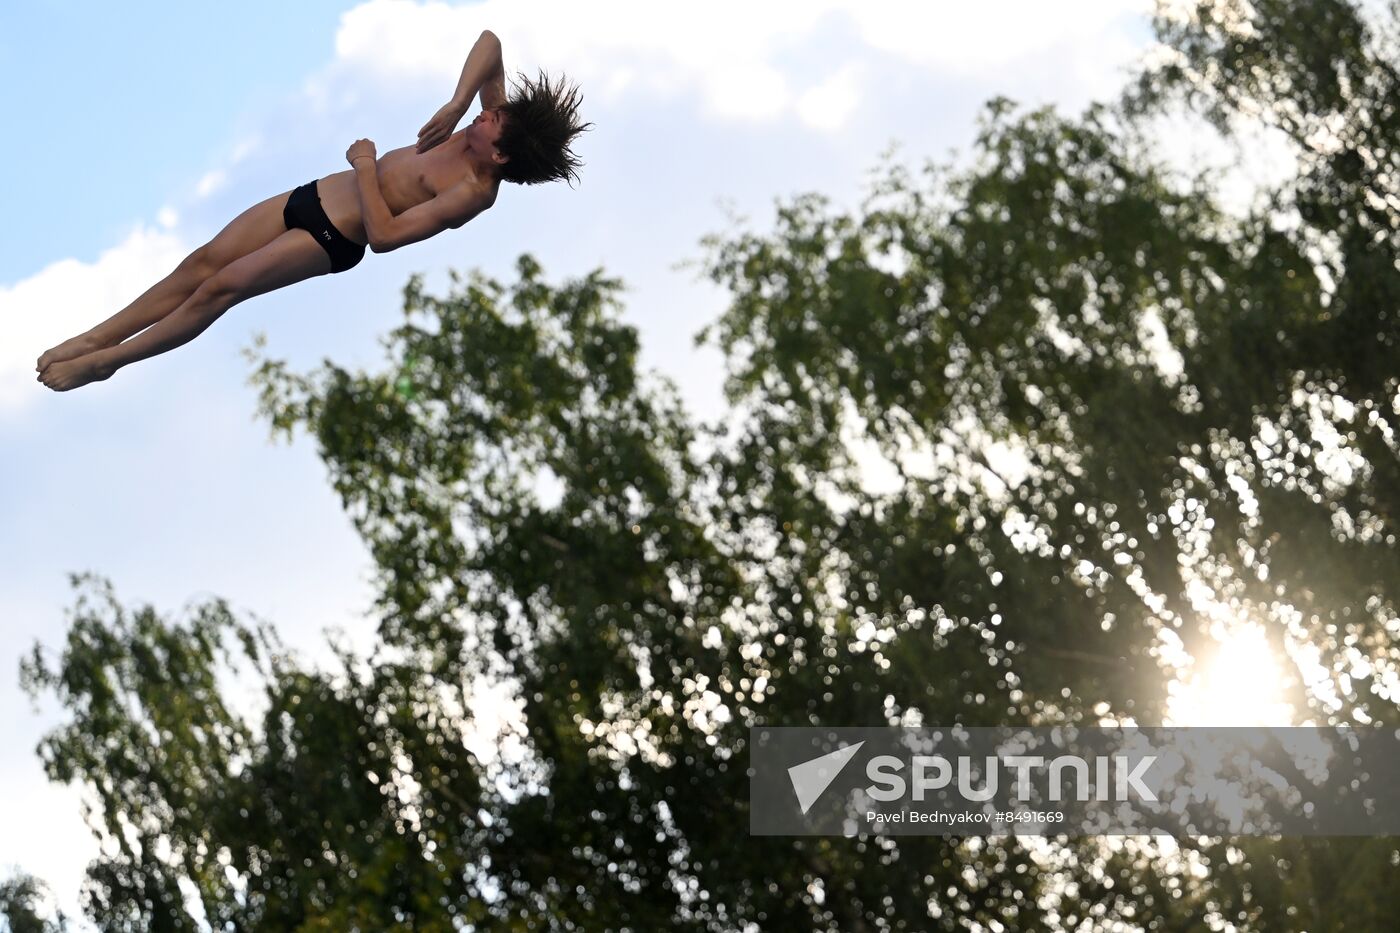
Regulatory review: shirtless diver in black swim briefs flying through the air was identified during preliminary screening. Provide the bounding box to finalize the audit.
[35,29,592,392]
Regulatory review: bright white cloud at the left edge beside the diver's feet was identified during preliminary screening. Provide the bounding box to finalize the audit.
[0,226,189,410]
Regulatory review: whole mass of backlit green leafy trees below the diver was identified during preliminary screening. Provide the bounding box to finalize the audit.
[16,3,1400,930]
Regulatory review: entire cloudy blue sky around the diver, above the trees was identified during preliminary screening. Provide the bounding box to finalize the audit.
[0,0,1148,906]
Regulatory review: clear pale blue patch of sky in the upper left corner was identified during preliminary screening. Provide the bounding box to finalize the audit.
[0,0,354,282]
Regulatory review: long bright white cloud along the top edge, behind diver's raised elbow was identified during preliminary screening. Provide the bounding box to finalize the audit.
[320,0,1148,132]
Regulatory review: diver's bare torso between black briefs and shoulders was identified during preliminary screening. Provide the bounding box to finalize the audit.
[316,127,500,247]
